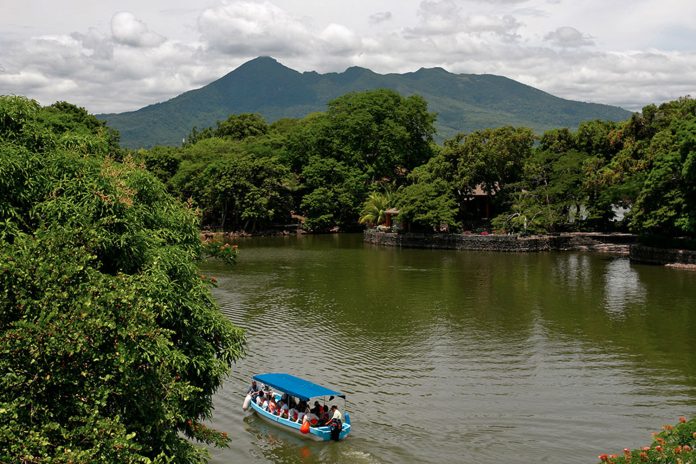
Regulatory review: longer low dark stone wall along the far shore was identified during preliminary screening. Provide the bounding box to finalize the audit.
[365,229,635,254]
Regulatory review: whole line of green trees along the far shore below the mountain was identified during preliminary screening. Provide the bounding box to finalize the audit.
[135,90,696,237]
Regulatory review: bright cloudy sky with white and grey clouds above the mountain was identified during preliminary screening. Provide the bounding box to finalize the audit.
[0,0,696,112]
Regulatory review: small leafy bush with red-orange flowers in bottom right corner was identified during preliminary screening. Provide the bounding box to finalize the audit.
[598,417,696,464]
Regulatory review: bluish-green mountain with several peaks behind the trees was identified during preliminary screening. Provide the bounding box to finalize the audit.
[97,57,631,148]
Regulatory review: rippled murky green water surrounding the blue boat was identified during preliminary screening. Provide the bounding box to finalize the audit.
[204,235,696,463]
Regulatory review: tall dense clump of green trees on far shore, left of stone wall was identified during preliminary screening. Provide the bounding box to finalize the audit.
[136,90,435,232]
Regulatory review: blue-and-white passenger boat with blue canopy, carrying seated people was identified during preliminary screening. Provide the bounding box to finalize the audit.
[242,372,351,441]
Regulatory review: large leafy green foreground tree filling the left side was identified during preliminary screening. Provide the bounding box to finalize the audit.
[0,97,243,463]
